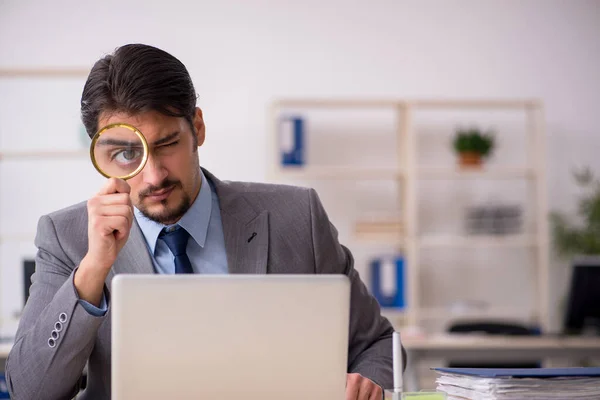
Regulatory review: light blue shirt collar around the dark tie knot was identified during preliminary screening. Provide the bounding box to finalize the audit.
[134,170,213,254]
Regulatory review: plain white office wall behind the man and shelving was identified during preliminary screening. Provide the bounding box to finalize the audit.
[0,0,600,332]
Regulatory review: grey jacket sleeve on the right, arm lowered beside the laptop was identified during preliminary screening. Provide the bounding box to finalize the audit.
[309,189,406,389]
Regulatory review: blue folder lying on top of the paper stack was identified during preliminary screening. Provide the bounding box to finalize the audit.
[433,367,600,378]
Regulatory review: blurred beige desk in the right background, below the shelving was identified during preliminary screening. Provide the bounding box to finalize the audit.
[402,334,600,391]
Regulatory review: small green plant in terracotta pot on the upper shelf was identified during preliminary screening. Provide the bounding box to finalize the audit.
[453,128,494,167]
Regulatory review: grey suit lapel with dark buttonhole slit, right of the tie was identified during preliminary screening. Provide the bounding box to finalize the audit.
[203,170,269,274]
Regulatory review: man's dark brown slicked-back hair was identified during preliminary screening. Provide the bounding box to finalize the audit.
[81,44,197,137]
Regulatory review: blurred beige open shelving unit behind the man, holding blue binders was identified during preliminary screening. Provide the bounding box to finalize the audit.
[267,99,549,329]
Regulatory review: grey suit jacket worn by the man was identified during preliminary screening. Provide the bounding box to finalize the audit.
[6,171,400,400]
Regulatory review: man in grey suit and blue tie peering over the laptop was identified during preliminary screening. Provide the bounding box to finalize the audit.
[6,45,400,400]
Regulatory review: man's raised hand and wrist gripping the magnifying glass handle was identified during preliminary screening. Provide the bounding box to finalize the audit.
[74,178,134,307]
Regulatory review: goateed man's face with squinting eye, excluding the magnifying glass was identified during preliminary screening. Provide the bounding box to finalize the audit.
[98,109,204,225]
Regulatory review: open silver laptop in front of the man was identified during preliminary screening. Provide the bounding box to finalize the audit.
[111,275,350,400]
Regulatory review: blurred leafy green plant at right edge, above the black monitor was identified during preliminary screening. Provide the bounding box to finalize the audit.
[550,168,600,257]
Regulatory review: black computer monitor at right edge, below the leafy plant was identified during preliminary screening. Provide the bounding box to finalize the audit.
[564,259,600,335]
